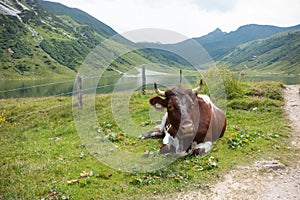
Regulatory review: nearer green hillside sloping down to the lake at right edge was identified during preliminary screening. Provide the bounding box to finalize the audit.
[222,30,300,74]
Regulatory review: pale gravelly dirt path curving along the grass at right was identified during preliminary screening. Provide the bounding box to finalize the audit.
[172,85,300,200]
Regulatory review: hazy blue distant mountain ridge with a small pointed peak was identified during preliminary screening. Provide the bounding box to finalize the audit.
[144,24,300,71]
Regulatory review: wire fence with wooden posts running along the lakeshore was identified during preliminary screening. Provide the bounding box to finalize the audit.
[0,67,193,119]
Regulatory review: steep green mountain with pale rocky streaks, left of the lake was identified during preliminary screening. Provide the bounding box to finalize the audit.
[0,0,183,79]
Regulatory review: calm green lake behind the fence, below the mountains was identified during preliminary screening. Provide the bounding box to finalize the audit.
[0,73,300,98]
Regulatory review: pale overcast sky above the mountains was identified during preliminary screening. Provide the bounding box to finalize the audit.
[48,0,300,43]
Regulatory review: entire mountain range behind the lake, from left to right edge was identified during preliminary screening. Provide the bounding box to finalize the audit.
[0,0,300,79]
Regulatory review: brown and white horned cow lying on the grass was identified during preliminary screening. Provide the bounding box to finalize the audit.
[140,80,226,156]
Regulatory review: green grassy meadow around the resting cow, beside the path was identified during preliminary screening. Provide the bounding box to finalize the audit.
[0,76,291,199]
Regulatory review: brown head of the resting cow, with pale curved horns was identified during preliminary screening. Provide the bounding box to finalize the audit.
[150,80,202,151]
